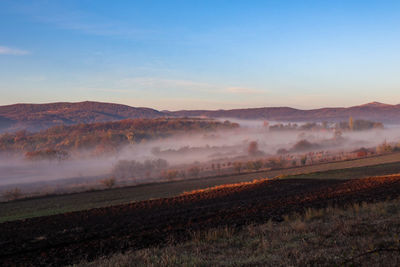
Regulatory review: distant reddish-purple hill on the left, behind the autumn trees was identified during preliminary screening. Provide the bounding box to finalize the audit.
[0,101,165,131]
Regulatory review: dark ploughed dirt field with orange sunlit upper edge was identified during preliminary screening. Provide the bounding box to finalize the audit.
[0,176,400,266]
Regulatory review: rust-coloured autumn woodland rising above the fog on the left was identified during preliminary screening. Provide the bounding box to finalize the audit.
[0,118,239,153]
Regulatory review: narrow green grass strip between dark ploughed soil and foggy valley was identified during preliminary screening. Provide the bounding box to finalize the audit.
[0,153,400,222]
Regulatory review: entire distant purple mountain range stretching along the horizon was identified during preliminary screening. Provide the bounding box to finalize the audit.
[0,101,400,132]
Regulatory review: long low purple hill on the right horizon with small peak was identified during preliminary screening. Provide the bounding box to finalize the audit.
[169,102,400,123]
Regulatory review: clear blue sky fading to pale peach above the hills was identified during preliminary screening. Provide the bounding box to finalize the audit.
[0,0,400,110]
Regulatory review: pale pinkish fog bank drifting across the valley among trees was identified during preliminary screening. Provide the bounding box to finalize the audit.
[0,119,400,196]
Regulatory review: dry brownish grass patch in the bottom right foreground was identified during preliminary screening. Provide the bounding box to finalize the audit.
[73,200,400,267]
